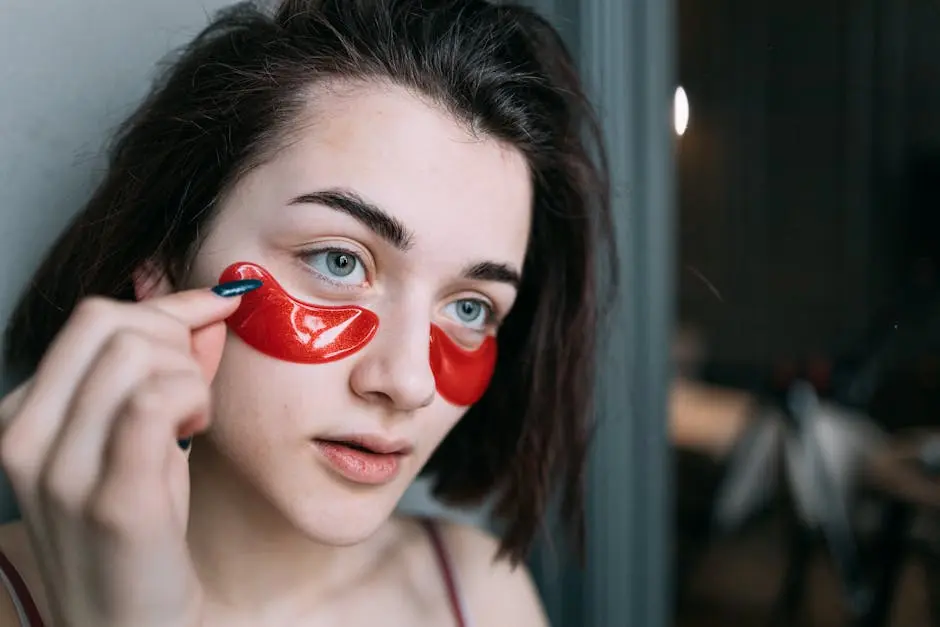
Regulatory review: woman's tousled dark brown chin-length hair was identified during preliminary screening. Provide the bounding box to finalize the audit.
[5,0,614,560]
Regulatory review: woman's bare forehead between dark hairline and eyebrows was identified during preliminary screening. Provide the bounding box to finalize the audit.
[229,84,532,265]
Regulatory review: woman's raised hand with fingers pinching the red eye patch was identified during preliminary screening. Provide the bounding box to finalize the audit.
[0,290,246,627]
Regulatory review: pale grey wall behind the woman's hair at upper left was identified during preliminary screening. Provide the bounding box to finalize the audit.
[0,0,479,522]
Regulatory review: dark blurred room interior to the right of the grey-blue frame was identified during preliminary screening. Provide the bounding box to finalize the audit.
[670,0,940,626]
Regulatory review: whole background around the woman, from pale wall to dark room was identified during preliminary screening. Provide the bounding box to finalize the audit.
[0,0,940,627]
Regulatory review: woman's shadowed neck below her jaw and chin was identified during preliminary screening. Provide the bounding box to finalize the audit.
[187,445,395,624]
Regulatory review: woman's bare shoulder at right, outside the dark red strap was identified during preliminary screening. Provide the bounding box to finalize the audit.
[440,522,548,627]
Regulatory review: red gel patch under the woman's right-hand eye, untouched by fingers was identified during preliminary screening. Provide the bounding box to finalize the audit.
[431,324,496,407]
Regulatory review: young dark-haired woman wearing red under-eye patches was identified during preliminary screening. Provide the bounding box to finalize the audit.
[0,0,613,627]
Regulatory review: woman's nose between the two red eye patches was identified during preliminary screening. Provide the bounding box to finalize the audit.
[350,316,435,412]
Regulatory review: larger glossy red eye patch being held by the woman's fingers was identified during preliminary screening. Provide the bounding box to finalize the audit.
[219,262,379,364]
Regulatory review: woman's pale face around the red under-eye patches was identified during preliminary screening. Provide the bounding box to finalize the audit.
[187,83,532,544]
